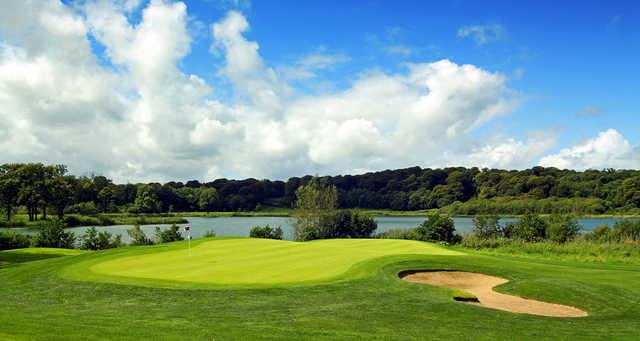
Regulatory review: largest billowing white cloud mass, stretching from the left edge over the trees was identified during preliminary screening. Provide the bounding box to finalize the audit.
[0,0,548,181]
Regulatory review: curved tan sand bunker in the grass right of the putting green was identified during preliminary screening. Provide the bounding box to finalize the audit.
[400,271,588,317]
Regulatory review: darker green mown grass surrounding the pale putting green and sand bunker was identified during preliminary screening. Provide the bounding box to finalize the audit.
[0,239,640,340]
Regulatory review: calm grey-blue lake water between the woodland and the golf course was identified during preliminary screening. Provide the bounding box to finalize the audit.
[3,216,636,243]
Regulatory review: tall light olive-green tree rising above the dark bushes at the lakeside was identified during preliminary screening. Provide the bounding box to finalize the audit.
[293,177,338,241]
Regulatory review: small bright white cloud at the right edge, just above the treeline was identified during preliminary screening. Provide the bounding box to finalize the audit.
[540,129,640,170]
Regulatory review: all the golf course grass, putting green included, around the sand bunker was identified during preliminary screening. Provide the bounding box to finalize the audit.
[0,238,640,340]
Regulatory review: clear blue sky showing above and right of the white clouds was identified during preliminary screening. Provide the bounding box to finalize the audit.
[195,1,640,148]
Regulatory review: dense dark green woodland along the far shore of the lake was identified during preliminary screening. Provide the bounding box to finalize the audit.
[0,163,640,220]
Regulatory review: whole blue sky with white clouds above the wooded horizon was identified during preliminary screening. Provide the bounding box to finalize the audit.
[0,0,640,183]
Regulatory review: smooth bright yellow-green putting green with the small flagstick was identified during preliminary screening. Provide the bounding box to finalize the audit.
[74,238,462,285]
